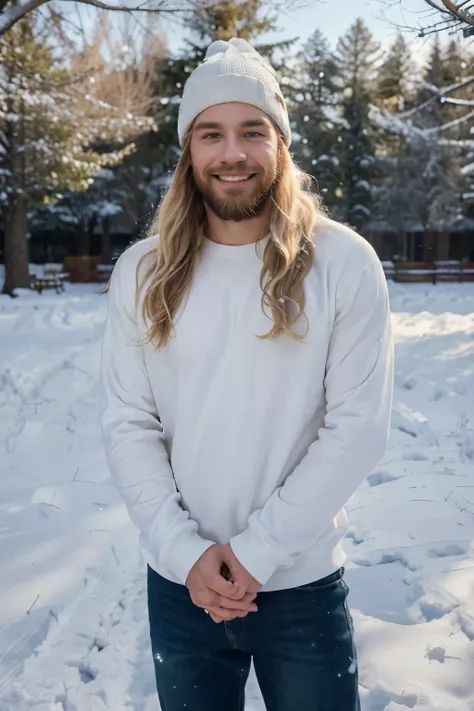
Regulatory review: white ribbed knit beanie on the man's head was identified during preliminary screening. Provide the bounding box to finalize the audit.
[178,38,291,146]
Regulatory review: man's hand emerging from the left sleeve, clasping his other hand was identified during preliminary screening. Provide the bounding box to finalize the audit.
[186,545,257,622]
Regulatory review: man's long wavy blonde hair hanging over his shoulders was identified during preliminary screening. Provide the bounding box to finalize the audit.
[137,134,324,349]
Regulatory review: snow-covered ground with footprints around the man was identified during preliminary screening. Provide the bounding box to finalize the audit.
[0,276,474,711]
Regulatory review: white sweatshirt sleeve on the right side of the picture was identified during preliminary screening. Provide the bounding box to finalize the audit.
[230,260,393,585]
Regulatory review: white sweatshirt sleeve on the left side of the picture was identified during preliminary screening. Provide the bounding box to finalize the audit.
[99,253,213,584]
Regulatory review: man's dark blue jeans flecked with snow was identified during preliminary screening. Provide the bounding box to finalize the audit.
[148,568,360,711]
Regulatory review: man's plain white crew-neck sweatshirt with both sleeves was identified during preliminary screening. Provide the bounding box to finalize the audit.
[100,220,393,591]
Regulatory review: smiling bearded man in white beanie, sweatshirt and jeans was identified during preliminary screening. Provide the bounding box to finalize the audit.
[101,39,393,711]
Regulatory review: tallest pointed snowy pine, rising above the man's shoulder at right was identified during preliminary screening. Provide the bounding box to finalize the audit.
[336,19,379,229]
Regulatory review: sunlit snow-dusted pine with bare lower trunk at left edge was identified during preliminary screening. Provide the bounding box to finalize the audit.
[0,16,156,295]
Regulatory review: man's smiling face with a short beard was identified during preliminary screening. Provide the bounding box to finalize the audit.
[191,102,279,222]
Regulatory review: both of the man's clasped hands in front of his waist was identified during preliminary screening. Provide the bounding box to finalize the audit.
[186,544,261,622]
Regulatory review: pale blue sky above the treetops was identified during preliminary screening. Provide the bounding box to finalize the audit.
[164,0,432,54]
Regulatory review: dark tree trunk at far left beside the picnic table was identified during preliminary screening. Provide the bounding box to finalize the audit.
[3,194,30,296]
